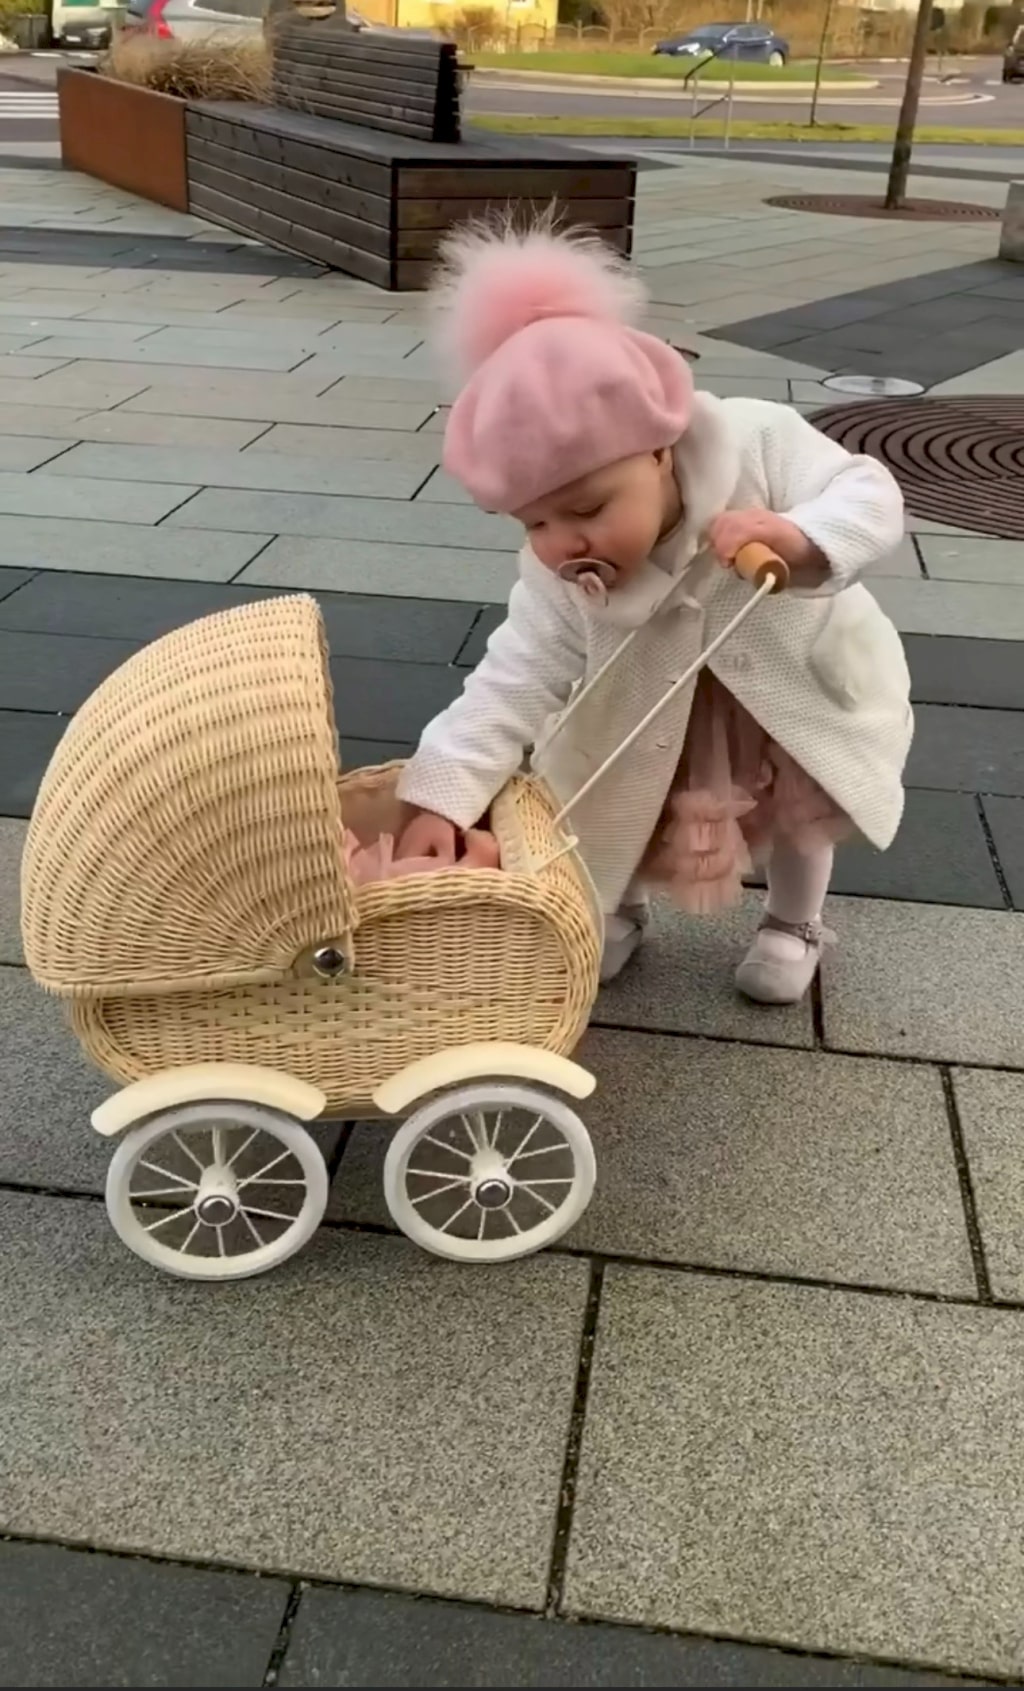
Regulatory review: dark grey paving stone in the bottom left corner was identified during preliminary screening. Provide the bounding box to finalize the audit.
[0,1544,289,1686]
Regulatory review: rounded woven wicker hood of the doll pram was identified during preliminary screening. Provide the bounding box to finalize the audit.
[22,595,355,998]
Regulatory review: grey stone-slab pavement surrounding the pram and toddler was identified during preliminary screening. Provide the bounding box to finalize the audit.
[0,154,1024,1686]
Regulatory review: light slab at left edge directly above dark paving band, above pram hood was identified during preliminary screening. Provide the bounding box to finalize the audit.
[3,517,270,582]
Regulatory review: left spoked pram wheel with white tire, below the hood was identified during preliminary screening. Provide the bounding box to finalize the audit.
[106,1099,328,1280]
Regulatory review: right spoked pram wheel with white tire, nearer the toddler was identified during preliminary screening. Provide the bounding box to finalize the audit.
[384,1081,595,1263]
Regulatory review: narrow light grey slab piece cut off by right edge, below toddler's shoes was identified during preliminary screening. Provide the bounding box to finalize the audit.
[953,1069,1024,1304]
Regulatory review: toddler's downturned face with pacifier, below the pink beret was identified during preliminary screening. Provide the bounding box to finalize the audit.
[514,448,681,577]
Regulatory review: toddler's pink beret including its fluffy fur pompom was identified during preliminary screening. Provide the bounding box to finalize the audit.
[429,220,693,511]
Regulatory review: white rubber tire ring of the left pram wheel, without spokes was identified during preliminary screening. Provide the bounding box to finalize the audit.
[106,1099,330,1280]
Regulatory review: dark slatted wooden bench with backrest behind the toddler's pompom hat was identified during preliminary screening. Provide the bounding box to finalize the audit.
[186,17,637,291]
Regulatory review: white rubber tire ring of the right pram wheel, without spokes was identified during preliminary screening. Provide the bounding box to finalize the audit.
[384,1081,596,1263]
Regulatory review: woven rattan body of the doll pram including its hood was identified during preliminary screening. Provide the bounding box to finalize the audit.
[22,597,600,1113]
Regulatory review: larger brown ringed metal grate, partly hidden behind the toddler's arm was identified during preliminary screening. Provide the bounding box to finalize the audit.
[811,394,1024,539]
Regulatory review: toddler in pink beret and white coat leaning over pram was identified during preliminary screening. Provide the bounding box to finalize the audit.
[399,223,912,1004]
